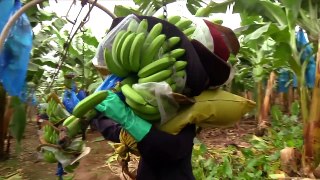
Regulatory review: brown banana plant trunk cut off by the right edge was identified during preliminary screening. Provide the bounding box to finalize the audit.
[303,35,320,175]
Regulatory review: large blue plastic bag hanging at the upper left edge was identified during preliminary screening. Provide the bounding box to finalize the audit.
[0,0,33,96]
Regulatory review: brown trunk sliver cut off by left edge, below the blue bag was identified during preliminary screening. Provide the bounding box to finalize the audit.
[0,84,7,159]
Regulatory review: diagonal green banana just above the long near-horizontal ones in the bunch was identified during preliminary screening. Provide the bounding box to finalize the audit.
[140,34,166,69]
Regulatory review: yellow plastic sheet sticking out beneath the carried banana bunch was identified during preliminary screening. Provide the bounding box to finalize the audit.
[159,89,256,134]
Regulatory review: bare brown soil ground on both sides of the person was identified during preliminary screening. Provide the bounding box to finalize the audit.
[0,119,256,180]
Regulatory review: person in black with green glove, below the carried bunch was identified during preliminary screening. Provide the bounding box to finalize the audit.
[93,91,196,180]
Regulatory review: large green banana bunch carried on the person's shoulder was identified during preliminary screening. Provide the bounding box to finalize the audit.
[103,16,195,122]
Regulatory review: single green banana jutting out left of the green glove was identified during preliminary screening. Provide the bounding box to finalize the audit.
[72,90,108,118]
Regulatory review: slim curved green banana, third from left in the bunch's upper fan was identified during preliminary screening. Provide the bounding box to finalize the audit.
[120,33,136,71]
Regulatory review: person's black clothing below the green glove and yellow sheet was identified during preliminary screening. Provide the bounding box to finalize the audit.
[93,117,196,180]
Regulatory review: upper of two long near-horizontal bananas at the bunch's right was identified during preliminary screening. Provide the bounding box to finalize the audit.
[138,57,176,78]
